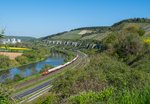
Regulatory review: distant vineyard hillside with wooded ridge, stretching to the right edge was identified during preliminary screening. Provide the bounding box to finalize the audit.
[43,18,150,40]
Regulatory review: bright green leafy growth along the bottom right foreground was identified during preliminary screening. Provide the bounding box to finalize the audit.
[67,87,150,104]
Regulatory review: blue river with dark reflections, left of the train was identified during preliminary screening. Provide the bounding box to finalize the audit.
[0,53,65,82]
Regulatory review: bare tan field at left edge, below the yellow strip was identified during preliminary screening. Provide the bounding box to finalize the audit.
[0,52,22,60]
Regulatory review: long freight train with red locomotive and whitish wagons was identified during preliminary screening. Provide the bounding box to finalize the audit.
[42,55,79,75]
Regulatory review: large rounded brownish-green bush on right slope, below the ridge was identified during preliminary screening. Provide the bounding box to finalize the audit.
[103,25,146,64]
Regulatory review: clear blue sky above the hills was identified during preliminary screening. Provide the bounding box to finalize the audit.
[0,0,150,37]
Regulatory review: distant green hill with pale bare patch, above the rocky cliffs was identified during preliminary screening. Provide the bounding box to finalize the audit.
[43,27,111,40]
